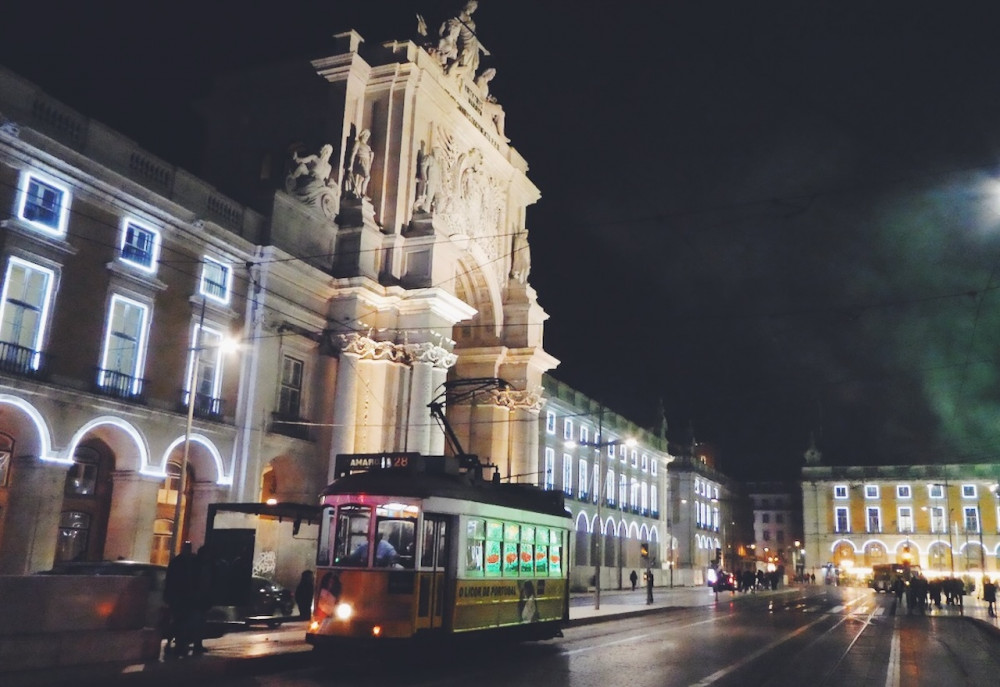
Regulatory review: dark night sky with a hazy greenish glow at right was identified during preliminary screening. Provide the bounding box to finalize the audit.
[0,0,1000,478]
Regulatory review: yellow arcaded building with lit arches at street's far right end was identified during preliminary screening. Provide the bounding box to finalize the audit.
[802,454,1000,580]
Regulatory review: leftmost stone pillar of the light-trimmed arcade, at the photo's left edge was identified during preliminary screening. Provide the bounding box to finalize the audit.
[0,456,68,575]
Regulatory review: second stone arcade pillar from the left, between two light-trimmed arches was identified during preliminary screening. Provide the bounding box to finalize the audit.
[104,470,163,562]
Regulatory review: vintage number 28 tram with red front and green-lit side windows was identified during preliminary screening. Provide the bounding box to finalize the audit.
[306,453,571,648]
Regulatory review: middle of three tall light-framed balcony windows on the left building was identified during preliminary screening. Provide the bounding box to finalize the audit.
[98,295,149,396]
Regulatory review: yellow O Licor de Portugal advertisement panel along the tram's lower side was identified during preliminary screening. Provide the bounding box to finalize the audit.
[452,578,566,632]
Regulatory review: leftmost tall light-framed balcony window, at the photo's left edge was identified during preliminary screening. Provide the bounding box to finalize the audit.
[0,257,54,370]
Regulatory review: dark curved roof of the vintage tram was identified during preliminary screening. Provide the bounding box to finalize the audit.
[323,460,568,516]
